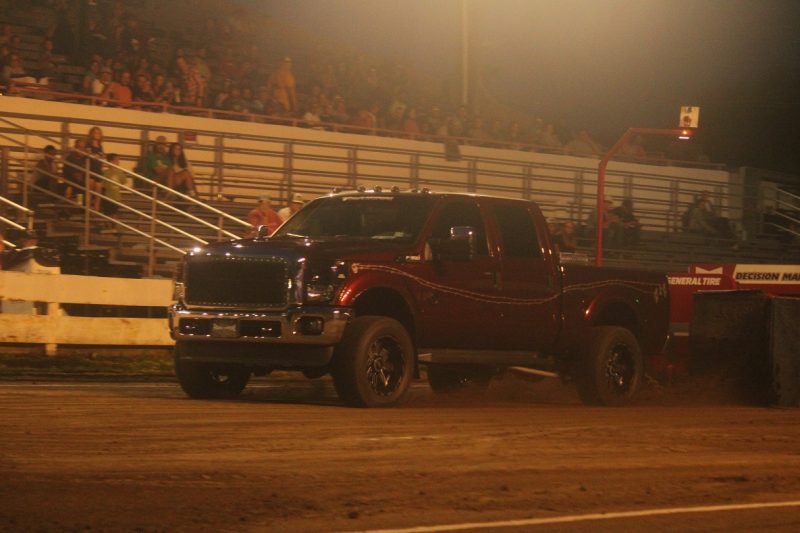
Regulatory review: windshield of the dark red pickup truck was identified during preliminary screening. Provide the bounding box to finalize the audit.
[273,194,436,242]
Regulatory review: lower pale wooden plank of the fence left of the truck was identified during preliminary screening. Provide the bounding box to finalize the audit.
[0,314,174,346]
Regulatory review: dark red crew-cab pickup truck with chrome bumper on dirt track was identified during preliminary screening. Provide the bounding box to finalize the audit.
[169,189,670,407]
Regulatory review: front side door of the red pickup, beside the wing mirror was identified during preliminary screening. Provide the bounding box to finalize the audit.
[418,198,498,349]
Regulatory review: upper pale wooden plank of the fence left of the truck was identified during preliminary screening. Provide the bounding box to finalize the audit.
[0,271,172,307]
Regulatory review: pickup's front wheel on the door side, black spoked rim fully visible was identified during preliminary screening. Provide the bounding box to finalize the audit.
[331,316,414,407]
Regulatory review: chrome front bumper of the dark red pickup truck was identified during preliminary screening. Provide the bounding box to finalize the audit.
[169,304,352,346]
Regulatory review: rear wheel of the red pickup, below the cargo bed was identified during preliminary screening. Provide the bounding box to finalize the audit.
[575,326,644,406]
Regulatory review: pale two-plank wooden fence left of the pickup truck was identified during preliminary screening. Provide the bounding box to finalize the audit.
[0,271,173,355]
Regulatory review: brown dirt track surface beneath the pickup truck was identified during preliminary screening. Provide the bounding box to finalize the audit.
[0,378,800,531]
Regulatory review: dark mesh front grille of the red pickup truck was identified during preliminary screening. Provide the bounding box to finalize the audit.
[185,257,288,307]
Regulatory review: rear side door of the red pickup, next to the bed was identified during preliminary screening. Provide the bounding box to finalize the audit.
[491,202,561,351]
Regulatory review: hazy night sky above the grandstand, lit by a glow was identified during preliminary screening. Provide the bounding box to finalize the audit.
[262,0,800,173]
